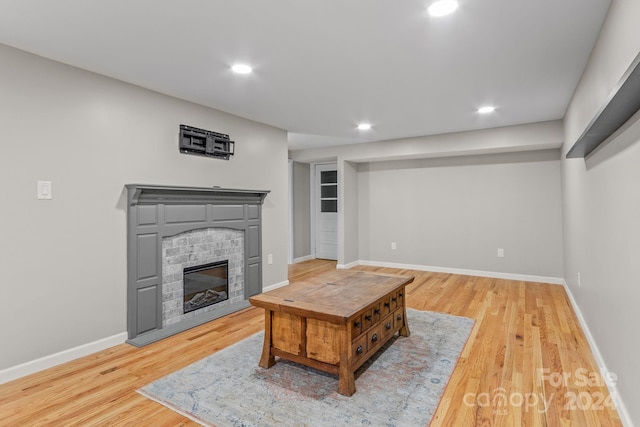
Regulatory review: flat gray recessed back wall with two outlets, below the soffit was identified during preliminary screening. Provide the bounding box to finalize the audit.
[358,150,563,278]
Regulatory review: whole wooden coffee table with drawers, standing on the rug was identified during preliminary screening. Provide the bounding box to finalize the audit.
[249,270,414,396]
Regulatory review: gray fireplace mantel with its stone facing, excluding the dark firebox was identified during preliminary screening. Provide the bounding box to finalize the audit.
[126,184,269,347]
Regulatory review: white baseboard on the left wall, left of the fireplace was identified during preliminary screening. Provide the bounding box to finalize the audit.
[0,332,127,384]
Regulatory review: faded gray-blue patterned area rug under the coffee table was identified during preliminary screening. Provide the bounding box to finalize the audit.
[138,309,474,427]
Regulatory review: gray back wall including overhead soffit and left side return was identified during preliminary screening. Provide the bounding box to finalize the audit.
[290,121,563,278]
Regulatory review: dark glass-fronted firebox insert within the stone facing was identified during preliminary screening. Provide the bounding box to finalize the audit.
[183,261,229,313]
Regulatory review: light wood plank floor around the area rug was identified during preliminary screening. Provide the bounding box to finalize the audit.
[0,260,621,426]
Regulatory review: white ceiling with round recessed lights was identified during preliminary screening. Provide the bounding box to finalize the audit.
[0,0,611,149]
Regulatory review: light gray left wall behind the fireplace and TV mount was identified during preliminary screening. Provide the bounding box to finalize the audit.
[0,45,288,370]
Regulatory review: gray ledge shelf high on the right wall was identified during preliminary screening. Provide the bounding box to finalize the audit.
[567,54,640,159]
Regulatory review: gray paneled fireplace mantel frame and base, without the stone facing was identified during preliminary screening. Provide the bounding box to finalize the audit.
[125,184,269,346]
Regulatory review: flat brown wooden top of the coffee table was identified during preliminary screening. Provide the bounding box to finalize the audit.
[249,270,414,324]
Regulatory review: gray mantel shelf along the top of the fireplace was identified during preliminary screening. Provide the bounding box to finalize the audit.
[126,184,270,206]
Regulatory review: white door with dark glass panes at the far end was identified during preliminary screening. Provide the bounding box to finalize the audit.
[315,164,338,260]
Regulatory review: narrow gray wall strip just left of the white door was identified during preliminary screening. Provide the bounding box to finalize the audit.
[292,162,311,260]
